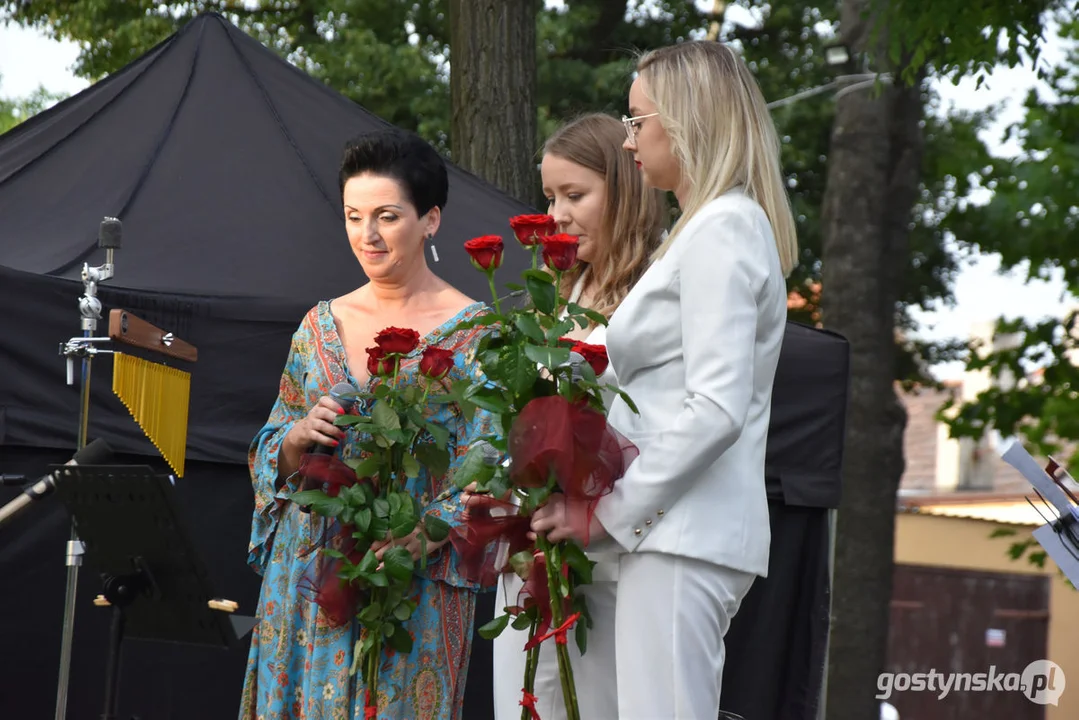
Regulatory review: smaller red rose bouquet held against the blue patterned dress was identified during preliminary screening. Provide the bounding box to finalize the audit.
[291,327,463,720]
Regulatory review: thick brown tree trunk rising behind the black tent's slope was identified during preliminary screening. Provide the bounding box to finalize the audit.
[450,0,538,205]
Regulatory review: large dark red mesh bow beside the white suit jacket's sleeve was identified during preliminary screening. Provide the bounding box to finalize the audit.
[509,395,638,538]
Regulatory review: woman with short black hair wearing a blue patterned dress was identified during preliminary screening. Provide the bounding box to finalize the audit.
[240,130,489,720]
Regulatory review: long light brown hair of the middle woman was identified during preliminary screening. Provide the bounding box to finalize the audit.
[543,113,667,317]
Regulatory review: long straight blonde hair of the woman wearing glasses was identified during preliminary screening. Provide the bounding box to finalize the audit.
[637,40,798,277]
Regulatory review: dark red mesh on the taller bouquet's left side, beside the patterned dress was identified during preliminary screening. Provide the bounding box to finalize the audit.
[450,495,532,587]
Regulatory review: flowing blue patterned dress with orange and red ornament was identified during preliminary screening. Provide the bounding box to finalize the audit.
[240,301,490,720]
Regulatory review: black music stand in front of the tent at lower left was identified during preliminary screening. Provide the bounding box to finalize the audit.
[50,465,256,720]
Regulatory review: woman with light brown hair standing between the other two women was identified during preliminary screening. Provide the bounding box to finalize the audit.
[493,114,667,720]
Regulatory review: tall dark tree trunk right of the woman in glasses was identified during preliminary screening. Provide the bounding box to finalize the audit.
[821,0,923,720]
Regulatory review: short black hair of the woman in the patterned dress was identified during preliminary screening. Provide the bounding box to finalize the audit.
[339,127,450,216]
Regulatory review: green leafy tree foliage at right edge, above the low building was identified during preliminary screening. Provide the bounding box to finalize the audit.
[942,18,1079,466]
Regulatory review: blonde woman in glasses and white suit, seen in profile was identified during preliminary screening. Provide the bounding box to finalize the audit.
[532,41,797,720]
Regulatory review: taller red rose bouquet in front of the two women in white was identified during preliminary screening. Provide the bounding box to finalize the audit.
[440,215,636,720]
